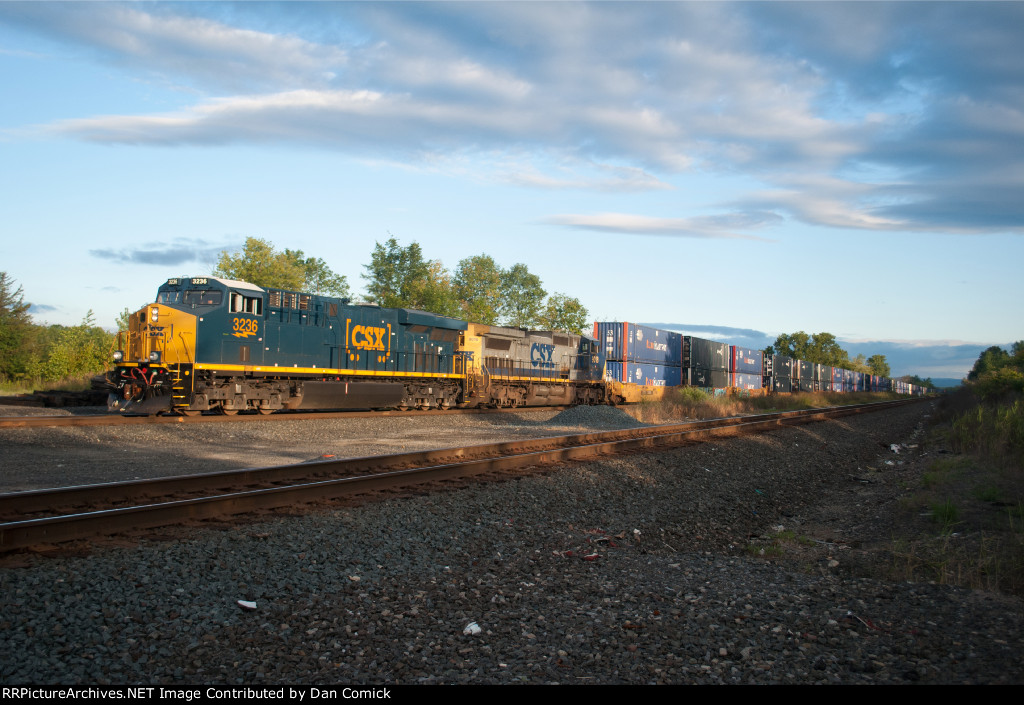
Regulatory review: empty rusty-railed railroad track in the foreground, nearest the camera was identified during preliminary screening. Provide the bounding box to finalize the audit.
[0,400,918,551]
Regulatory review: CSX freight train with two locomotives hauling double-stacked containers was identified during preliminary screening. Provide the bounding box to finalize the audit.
[106,277,929,415]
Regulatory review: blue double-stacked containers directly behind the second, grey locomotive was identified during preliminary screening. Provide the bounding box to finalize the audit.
[594,322,683,386]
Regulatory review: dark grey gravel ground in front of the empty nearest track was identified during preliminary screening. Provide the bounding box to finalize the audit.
[0,405,1024,685]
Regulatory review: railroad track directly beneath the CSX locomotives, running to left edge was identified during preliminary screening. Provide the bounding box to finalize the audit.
[0,406,570,428]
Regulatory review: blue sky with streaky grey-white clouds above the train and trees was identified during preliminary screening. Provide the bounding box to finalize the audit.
[0,1,1024,378]
